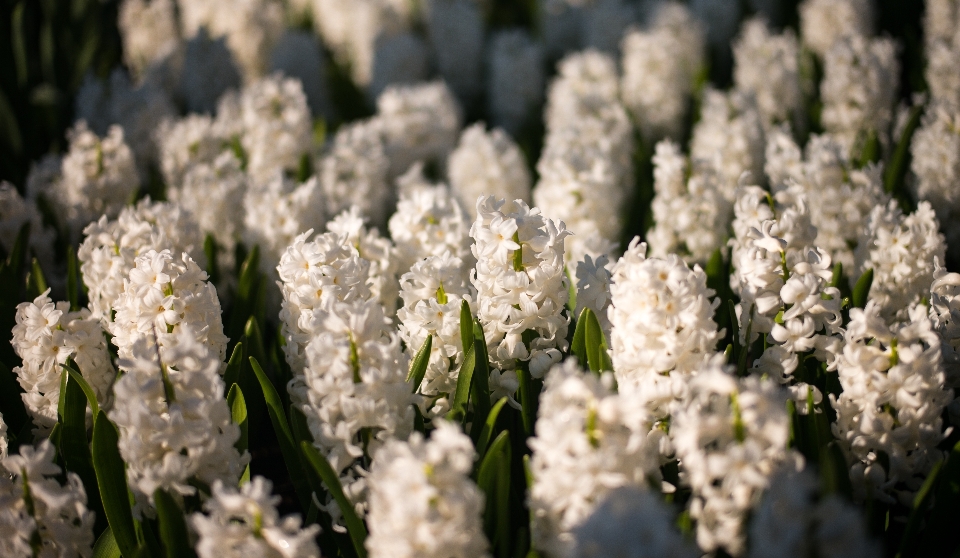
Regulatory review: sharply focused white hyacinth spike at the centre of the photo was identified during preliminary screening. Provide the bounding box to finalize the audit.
[470,196,570,384]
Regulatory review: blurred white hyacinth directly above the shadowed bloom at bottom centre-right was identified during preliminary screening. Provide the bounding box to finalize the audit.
[528,360,665,558]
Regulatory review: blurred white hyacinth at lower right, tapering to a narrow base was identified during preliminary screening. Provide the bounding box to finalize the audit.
[670,366,800,556]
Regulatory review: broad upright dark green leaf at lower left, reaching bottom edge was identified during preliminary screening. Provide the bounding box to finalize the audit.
[93,418,138,556]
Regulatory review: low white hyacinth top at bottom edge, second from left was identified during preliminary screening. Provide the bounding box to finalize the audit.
[190,477,320,558]
